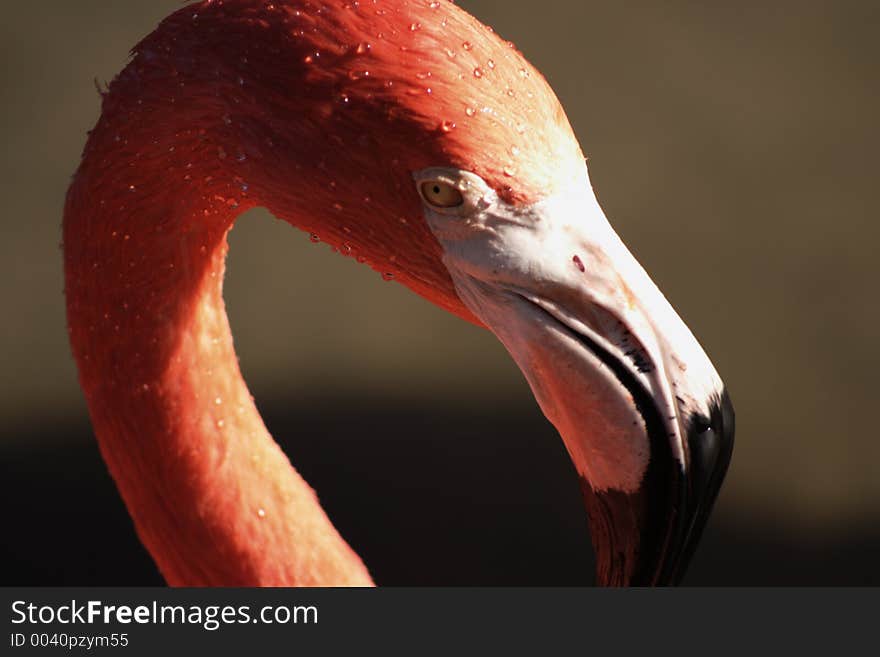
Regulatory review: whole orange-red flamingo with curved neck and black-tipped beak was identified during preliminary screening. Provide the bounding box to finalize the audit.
[63,0,733,586]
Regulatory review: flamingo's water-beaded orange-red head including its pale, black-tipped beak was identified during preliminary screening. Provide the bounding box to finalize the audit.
[146,0,733,585]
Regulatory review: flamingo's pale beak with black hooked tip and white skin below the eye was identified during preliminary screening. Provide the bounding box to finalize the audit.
[427,164,734,586]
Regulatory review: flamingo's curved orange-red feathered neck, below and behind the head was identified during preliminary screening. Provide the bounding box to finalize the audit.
[64,67,371,586]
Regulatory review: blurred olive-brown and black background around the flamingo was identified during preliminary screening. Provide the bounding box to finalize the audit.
[0,0,880,585]
